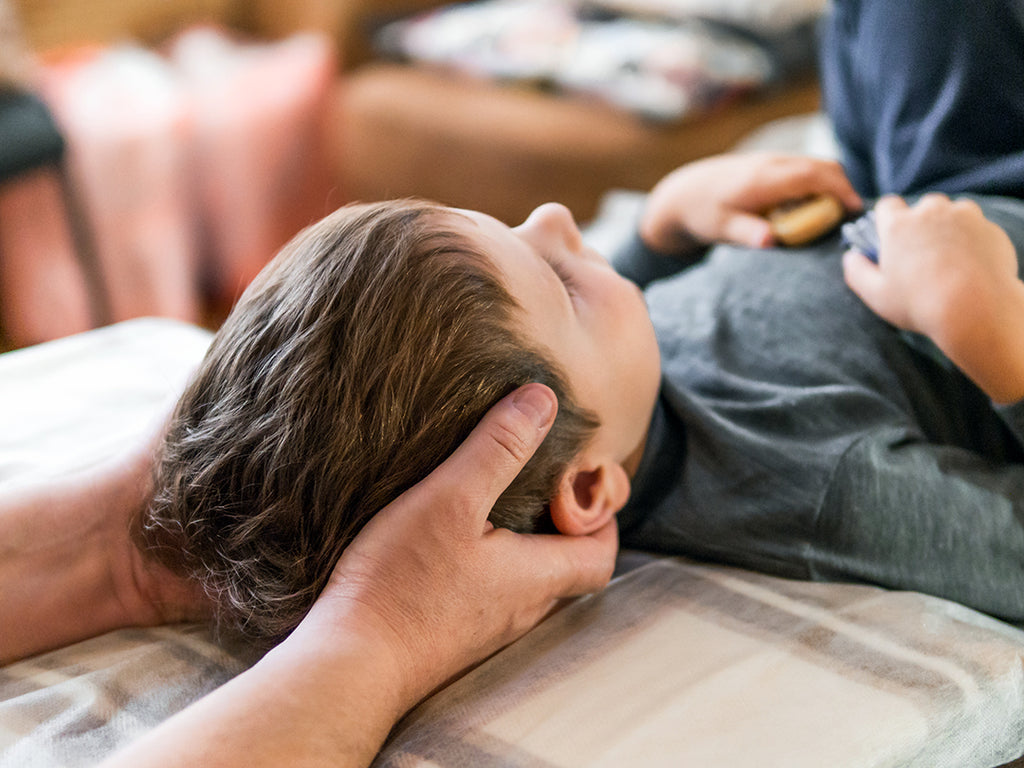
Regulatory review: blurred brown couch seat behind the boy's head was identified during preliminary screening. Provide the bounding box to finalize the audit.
[332,0,819,224]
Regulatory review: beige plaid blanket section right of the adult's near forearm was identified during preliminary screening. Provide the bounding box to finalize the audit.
[378,560,1024,768]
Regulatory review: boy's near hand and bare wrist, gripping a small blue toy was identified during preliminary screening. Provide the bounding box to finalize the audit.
[843,195,1024,401]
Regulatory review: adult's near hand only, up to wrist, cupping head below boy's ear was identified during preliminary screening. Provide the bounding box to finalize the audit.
[296,384,617,703]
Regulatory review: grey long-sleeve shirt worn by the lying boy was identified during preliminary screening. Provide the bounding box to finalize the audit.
[616,198,1024,622]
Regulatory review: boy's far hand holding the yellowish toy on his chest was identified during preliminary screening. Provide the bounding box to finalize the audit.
[640,153,863,254]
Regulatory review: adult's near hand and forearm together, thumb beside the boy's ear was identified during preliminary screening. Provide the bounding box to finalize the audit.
[104,384,617,768]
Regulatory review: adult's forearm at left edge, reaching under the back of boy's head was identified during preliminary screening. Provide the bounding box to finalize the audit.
[0,445,201,664]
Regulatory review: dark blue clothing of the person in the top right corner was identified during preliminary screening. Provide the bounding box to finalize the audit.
[821,0,1024,198]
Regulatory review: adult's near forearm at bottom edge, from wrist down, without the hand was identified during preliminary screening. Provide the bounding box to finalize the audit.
[101,628,415,768]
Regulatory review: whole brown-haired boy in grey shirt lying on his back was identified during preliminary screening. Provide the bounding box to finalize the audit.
[142,144,1024,640]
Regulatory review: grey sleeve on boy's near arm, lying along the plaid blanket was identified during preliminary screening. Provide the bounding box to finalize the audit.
[807,423,1024,624]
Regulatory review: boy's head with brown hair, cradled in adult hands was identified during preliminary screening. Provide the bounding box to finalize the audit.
[137,201,657,642]
